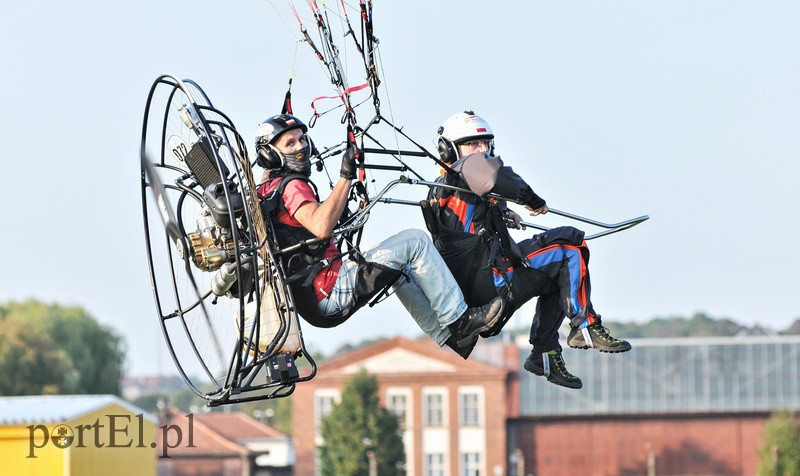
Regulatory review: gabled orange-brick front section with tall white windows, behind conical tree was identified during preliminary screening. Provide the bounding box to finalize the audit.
[292,337,510,476]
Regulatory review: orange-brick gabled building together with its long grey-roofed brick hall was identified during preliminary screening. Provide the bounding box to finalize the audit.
[292,336,800,476]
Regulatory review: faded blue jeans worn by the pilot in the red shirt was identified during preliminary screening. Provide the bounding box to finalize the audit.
[319,229,467,345]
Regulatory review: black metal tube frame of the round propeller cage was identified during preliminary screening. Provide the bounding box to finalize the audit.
[140,74,317,406]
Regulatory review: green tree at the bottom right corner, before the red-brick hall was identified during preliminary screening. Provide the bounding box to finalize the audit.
[758,412,800,476]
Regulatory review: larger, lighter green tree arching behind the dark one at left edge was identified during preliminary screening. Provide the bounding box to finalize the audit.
[0,300,125,395]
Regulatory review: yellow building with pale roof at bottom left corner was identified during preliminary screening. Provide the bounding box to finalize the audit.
[0,395,157,476]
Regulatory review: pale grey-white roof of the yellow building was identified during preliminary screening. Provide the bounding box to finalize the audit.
[0,395,156,426]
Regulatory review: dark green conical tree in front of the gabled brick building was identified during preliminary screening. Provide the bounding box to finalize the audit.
[319,370,405,476]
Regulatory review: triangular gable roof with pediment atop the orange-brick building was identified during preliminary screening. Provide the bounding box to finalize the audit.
[316,337,508,380]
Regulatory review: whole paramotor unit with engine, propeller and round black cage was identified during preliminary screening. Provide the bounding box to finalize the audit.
[141,74,316,405]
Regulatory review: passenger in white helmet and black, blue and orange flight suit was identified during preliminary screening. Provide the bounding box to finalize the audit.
[426,111,631,388]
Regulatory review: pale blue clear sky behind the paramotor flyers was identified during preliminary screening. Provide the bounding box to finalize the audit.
[0,0,800,375]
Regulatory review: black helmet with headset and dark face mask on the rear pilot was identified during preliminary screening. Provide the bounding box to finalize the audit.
[256,114,311,175]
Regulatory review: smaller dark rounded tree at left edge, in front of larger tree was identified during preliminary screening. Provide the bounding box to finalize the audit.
[0,318,76,395]
